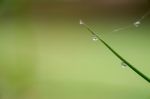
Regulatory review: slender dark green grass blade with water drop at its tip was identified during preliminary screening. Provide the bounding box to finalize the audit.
[80,20,150,83]
